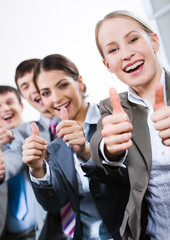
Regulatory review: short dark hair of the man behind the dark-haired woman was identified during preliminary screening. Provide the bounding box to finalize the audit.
[15,58,40,90]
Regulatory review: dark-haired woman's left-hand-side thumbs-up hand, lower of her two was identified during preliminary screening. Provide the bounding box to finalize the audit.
[22,122,47,178]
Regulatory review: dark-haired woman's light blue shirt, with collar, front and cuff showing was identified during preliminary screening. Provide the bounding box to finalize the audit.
[31,103,113,240]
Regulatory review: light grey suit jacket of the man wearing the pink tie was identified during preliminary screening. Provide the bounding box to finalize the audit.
[0,118,65,240]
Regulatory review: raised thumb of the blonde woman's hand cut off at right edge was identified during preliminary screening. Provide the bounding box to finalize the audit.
[154,82,165,111]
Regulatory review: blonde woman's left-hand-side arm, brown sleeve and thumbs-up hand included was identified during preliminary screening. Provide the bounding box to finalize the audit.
[90,90,133,173]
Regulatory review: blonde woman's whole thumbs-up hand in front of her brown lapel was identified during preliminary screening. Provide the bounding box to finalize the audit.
[102,88,133,159]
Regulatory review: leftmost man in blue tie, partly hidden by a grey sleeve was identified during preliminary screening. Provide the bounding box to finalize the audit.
[0,85,35,240]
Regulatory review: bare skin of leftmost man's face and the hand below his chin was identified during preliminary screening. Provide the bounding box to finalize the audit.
[0,92,24,144]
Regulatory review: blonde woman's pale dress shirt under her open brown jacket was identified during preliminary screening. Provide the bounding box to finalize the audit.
[128,70,170,240]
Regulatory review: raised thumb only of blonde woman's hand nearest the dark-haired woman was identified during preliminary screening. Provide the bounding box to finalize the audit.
[109,88,124,113]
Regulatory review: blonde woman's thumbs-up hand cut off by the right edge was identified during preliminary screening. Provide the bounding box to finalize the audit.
[151,82,170,146]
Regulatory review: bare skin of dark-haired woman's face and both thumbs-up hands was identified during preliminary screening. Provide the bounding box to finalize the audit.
[23,70,90,178]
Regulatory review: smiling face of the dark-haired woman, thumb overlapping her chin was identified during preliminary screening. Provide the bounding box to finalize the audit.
[37,70,86,120]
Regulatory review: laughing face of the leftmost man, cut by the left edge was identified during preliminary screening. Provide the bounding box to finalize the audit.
[0,92,23,129]
